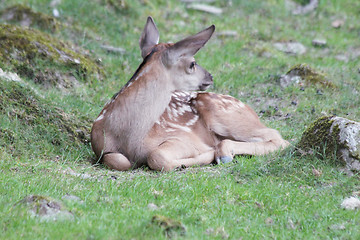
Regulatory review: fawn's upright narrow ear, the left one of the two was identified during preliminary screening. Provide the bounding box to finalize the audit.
[139,16,160,58]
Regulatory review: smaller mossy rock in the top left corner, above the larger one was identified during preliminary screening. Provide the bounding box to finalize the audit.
[0,4,60,32]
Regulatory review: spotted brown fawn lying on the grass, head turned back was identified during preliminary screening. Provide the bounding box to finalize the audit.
[91,17,288,171]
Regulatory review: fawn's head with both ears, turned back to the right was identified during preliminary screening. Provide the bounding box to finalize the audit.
[139,17,215,90]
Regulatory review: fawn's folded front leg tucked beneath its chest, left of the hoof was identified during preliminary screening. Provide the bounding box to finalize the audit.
[147,140,215,171]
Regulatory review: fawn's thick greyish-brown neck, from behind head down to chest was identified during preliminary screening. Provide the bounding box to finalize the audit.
[108,62,175,161]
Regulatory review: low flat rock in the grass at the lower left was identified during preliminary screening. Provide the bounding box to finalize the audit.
[20,195,74,221]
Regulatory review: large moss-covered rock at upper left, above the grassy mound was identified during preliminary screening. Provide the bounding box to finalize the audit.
[0,24,103,87]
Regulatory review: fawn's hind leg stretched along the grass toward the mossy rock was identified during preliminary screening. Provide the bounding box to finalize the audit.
[215,128,289,163]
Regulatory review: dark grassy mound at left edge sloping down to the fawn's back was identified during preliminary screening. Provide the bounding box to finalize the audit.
[0,69,91,155]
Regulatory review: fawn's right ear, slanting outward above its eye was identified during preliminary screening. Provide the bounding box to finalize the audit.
[162,25,215,66]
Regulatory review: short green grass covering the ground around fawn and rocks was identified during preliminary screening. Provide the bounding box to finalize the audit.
[0,0,360,239]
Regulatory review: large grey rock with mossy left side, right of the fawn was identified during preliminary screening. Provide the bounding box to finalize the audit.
[297,116,360,171]
